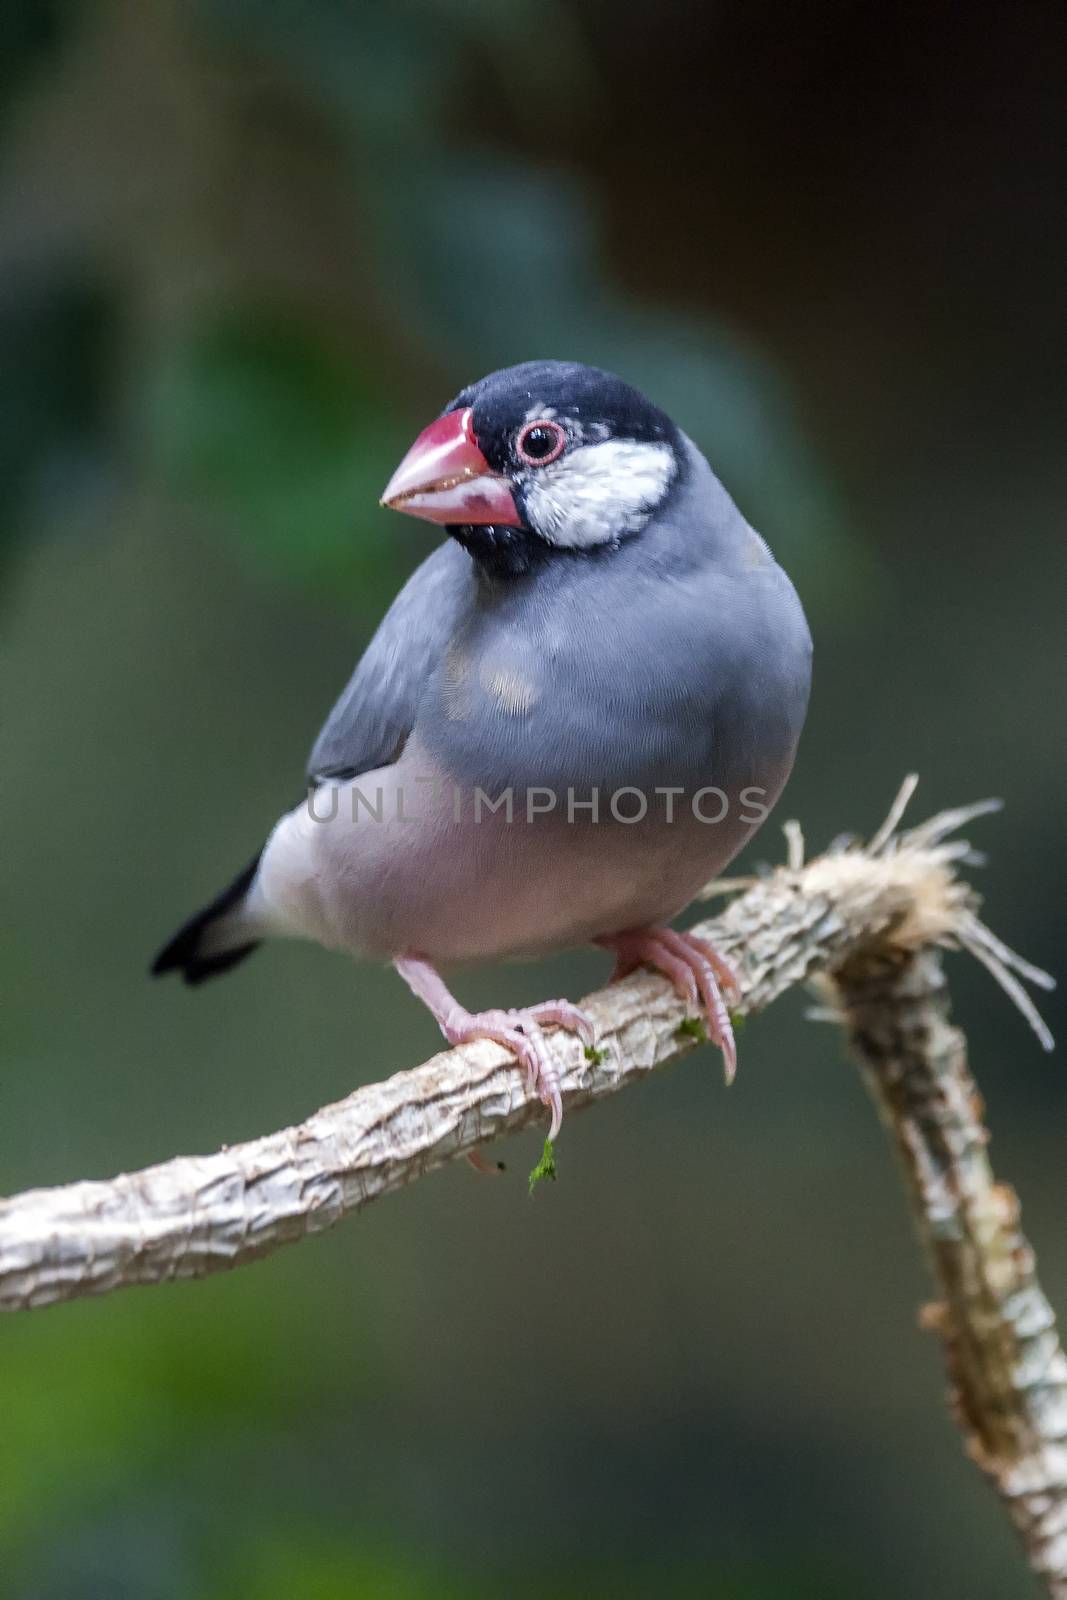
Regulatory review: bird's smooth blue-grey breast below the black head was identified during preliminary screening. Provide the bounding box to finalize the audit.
[418,441,811,806]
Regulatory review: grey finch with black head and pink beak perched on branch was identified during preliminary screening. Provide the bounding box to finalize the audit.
[152,360,811,1139]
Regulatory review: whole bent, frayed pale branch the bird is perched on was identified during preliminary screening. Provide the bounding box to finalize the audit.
[0,779,1067,1600]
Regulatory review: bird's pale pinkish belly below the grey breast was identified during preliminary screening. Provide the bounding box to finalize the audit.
[262,762,781,963]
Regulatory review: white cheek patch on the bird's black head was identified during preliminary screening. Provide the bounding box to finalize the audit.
[523,438,675,550]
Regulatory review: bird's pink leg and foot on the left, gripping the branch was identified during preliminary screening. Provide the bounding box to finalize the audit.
[394,955,597,1139]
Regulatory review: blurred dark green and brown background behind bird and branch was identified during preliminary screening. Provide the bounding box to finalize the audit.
[0,0,1067,1600]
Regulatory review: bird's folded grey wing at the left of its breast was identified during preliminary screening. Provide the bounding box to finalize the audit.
[307,539,474,784]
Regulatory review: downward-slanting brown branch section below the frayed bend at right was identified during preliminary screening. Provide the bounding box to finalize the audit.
[835,950,1067,1600]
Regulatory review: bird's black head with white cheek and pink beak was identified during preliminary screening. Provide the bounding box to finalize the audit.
[382,362,683,574]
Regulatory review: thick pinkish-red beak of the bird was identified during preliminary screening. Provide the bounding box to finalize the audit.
[382,406,522,528]
